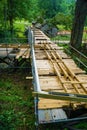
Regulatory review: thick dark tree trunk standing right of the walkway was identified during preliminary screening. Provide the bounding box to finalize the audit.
[70,0,87,49]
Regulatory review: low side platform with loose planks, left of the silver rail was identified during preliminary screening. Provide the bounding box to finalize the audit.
[0,44,30,59]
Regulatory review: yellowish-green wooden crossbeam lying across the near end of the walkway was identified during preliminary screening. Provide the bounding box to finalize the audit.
[33,91,87,102]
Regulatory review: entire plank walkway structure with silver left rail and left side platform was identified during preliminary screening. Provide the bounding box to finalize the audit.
[0,28,87,129]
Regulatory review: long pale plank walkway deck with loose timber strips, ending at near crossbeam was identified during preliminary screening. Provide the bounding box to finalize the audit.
[34,29,87,109]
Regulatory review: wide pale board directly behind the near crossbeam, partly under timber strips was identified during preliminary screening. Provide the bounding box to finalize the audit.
[39,76,84,94]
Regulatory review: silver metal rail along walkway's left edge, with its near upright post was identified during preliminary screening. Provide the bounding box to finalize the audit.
[28,28,41,130]
